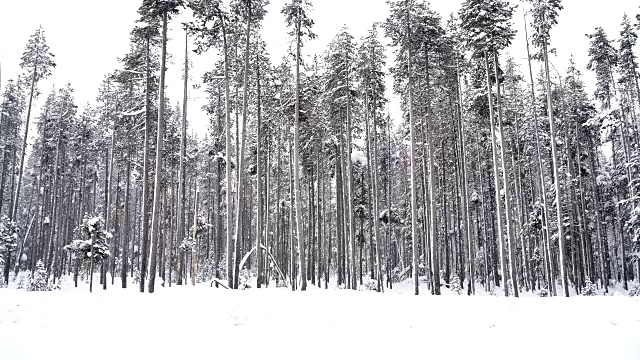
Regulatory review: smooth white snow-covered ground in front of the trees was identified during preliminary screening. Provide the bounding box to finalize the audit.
[0,279,640,360]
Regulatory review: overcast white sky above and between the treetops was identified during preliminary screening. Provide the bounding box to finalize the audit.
[0,0,640,146]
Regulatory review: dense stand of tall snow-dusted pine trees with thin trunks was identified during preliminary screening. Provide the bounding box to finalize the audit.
[0,0,640,309]
